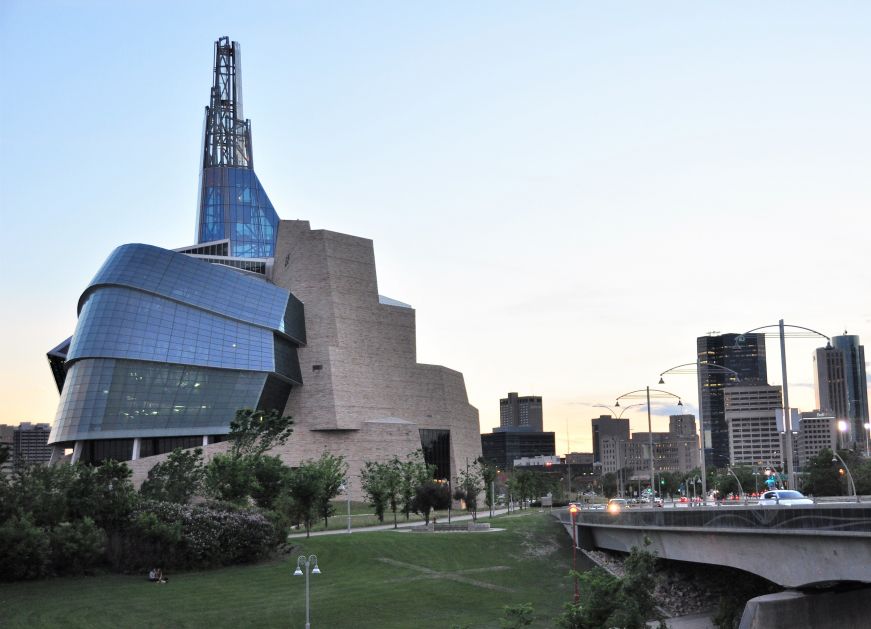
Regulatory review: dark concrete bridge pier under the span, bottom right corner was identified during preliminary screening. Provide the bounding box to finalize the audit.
[739,587,871,629]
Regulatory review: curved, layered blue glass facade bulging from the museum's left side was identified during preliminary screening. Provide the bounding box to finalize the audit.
[50,245,305,448]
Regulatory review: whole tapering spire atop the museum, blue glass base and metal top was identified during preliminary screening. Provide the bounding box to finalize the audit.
[196,37,278,258]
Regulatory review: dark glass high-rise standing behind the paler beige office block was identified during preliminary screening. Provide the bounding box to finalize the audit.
[696,333,768,468]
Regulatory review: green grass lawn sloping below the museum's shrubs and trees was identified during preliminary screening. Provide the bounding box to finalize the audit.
[0,510,572,629]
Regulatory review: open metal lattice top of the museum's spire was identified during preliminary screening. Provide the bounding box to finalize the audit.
[203,36,254,168]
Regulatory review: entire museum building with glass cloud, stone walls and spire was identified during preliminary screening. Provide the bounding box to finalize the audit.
[48,37,481,496]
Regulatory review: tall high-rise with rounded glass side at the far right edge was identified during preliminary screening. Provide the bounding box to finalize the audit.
[814,332,868,449]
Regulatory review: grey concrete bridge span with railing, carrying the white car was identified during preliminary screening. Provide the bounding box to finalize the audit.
[559,503,871,588]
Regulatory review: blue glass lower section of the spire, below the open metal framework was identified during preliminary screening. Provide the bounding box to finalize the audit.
[197,166,279,258]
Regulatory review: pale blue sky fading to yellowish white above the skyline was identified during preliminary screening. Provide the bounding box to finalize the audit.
[0,0,871,452]
